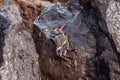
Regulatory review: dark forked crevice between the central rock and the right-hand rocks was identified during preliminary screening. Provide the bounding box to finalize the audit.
[80,1,120,80]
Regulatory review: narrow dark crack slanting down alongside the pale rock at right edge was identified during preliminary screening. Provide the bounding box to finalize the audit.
[90,0,120,65]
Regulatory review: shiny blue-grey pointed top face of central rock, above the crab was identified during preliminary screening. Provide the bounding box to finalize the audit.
[34,5,73,39]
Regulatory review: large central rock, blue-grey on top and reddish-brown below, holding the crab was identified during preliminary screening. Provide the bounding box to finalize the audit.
[34,0,96,80]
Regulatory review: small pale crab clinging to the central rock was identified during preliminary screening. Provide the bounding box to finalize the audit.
[50,22,70,60]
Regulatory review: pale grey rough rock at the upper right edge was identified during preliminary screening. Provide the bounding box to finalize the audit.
[106,0,120,52]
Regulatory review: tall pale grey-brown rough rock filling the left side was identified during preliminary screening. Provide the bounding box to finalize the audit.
[0,5,40,80]
